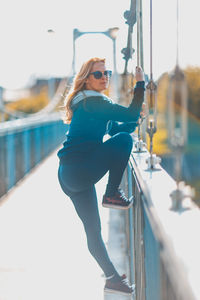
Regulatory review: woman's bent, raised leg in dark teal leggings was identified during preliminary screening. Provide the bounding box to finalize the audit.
[63,132,133,196]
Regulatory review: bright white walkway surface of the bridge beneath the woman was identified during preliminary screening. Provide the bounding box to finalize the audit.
[0,151,133,300]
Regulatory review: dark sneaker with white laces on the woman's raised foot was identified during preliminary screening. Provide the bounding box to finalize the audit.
[102,189,133,209]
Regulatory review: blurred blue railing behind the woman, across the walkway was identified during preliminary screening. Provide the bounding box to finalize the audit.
[0,113,67,197]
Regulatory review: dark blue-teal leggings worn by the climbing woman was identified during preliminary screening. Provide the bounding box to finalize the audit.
[58,132,133,277]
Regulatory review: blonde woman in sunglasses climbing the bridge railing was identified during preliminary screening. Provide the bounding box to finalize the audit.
[58,58,144,294]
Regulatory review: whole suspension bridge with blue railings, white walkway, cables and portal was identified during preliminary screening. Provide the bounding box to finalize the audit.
[0,0,200,300]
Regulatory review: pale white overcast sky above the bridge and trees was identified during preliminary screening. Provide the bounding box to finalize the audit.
[0,0,200,89]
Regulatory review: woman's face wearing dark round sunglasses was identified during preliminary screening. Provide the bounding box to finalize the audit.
[86,62,110,93]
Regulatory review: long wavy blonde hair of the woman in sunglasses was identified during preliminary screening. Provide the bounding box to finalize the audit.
[64,57,106,124]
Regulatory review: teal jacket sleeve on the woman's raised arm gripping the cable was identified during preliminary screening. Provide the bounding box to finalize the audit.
[84,81,145,123]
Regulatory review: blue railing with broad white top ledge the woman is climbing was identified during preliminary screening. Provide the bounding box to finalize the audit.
[124,138,200,300]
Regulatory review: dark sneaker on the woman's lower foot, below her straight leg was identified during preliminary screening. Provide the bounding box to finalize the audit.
[104,274,135,295]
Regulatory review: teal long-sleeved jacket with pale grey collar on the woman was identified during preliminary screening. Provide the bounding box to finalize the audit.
[58,81,145,163]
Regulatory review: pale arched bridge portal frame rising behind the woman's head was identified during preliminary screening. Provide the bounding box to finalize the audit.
[72,27,119,78]
